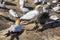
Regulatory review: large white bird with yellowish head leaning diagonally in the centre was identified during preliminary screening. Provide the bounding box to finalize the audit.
[20,5,41,20]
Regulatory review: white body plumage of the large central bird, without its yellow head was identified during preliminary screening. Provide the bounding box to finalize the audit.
[20,10,39,20]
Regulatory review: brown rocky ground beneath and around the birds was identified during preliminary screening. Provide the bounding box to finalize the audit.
[0,0,60,40]
